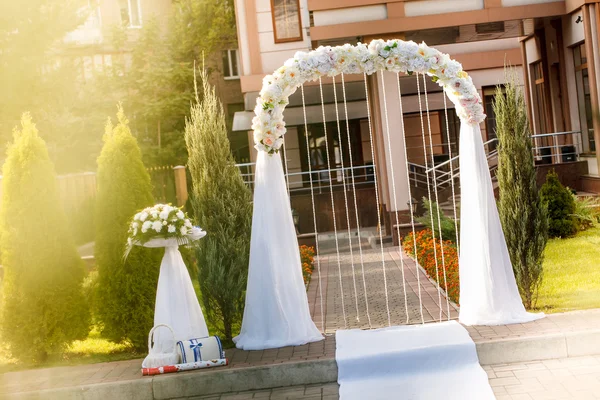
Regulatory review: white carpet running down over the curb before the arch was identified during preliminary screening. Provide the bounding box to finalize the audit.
[335,321,495,400]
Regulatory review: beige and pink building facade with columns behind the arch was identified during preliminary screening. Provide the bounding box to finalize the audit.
[234,0,600,233]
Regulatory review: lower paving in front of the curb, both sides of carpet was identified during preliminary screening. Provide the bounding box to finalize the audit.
[188,356,600,400]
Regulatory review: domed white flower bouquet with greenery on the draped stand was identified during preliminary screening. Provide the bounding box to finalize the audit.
[125,204,206,256]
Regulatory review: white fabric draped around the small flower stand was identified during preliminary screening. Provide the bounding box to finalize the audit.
[144,236,208,353]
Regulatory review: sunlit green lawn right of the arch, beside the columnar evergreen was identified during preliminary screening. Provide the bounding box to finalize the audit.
[537,226,600,312]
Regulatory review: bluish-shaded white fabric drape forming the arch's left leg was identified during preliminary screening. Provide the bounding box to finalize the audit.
[233,151,323,350]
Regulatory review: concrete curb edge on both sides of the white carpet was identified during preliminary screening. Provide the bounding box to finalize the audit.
[7,330,600,400]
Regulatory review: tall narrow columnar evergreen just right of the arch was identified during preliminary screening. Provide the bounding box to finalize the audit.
[494,72,548,308]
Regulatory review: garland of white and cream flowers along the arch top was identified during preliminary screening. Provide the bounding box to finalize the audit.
[252,39,485,154]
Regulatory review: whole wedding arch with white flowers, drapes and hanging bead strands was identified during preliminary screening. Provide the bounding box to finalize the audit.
[235,40,540,350]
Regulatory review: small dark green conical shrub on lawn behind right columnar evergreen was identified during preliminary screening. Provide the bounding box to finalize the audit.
[541,171,577,238]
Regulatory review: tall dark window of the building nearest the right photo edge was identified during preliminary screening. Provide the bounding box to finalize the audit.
[573,43,596,152]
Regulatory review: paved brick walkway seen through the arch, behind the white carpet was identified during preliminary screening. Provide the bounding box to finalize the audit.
[308,246,458,333]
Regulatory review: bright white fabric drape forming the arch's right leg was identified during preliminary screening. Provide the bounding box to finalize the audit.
[459,122,544,325]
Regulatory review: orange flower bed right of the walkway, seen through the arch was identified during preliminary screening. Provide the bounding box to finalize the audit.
[402,229,459,304]
